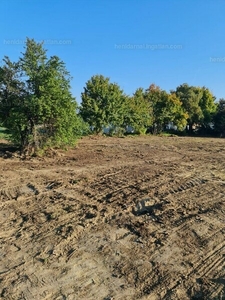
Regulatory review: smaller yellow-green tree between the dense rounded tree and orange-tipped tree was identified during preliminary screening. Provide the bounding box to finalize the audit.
[124,88,152,134]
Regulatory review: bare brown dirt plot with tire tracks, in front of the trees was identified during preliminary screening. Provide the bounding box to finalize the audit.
[0,136,225,300]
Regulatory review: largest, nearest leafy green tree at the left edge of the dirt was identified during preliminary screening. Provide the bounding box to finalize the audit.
[0,39,81,151]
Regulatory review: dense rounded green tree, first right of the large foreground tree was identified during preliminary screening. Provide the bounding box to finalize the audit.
[80,75,125,133]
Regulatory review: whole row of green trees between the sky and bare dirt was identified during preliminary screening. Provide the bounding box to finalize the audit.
[0,38,225,153]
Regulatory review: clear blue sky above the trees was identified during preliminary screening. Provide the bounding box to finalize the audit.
[0,0,225,102]
